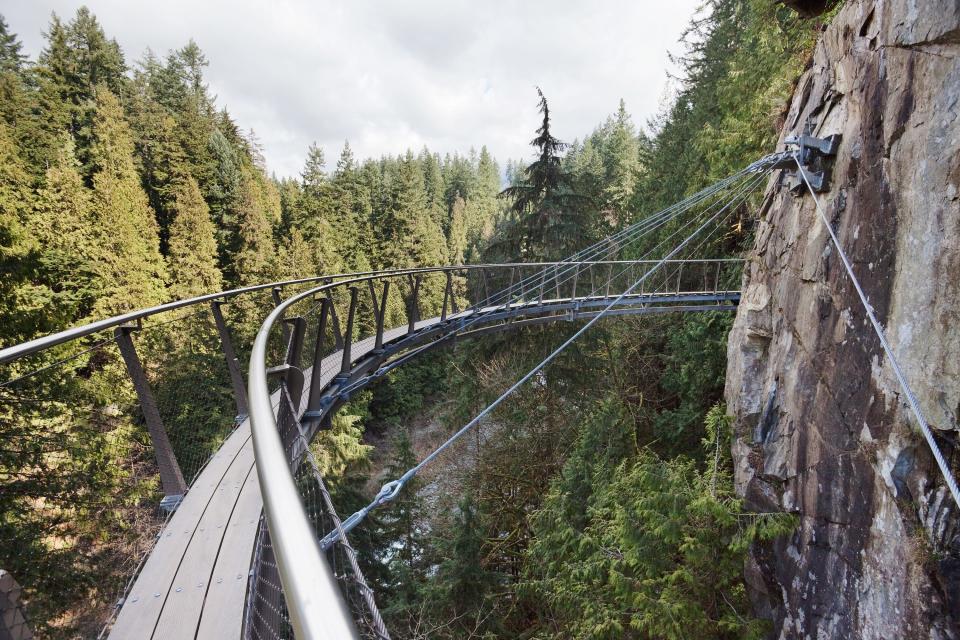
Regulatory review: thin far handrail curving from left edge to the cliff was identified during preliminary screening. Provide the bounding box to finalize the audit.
[0,258,742,364]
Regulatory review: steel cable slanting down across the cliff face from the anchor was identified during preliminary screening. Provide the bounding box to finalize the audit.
[793,153,960,507]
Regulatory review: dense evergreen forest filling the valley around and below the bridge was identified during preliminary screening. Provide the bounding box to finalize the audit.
[0,0,829,639]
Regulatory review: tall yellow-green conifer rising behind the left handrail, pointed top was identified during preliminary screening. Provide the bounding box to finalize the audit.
[90,87,167,317]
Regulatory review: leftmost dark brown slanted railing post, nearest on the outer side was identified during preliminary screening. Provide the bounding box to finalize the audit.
[113,325,187,500]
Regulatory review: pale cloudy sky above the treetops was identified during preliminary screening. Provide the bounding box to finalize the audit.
[0,0,700,177]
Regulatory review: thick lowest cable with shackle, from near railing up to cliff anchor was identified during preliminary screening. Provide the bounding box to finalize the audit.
[320,170,765,550]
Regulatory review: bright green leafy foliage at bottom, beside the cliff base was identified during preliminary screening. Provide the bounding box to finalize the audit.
[521,406,795,638]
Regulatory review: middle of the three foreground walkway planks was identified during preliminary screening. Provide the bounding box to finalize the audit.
[153,446,253,640]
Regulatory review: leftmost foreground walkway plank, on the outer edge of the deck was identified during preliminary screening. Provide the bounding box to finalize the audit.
[110,421,250,640]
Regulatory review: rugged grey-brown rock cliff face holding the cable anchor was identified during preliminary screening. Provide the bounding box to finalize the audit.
[726,0,960,639]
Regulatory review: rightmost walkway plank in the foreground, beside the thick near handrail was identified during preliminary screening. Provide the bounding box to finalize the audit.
[197,466,263,640]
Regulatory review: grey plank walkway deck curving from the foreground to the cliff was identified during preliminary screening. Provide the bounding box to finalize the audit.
[109,291,739,640]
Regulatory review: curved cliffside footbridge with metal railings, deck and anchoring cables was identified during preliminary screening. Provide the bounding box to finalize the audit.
[0,135,957,639]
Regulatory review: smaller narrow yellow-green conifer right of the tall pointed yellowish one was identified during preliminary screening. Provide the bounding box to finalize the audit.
[167,176,223,299]
